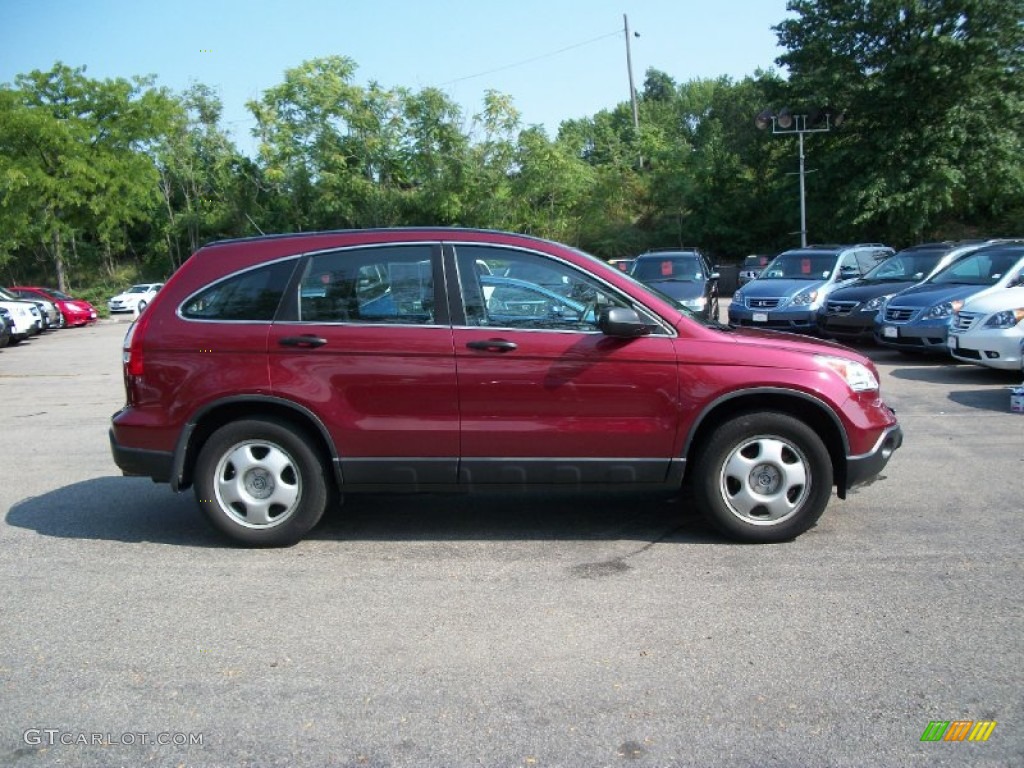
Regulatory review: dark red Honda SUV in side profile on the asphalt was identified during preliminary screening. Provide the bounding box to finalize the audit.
[110,228,902,546]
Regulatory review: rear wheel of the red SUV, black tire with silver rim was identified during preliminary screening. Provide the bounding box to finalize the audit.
[194,419,329,547]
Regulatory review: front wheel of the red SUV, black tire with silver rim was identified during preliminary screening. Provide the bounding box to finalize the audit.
[692,412,833,544]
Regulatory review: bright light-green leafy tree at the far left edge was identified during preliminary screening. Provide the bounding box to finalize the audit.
[0,62,168,290]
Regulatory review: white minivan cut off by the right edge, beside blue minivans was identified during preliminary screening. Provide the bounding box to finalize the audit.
[947,286,1024,371]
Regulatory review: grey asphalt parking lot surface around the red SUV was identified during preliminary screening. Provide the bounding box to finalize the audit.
[0,322,1024,768]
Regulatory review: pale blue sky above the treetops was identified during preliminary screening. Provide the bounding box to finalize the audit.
[0,0,787,153]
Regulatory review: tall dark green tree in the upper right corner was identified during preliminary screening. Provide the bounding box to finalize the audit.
[775,0,1024,242]
